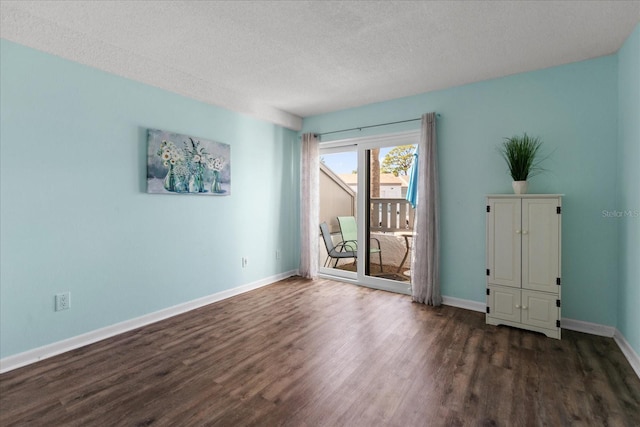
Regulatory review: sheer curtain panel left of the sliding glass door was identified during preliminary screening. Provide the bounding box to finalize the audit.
[300,133,320,279]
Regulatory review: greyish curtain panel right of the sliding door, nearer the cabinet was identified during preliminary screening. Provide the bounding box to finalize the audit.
[411,113,442,305]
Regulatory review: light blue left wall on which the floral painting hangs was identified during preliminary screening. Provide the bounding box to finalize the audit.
[0,40,299,357]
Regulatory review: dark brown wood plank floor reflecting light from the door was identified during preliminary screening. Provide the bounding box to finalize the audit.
[0,278,640,426]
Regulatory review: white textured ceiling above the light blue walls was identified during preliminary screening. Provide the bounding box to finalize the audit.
[0,0,640,129]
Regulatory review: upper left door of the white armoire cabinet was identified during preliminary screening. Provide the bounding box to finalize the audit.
[487,198,522,288]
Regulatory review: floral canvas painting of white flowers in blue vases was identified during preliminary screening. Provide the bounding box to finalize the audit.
[147,129,231,196]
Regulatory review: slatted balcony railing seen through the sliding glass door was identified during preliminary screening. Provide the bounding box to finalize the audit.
[369,198,415,232]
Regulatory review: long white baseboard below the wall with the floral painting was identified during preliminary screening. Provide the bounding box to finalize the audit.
[0,270,298,374]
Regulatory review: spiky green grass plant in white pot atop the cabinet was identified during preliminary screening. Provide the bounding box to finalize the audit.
[499,132,544,194]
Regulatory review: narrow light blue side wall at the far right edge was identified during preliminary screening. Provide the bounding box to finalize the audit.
[612,25,640,354]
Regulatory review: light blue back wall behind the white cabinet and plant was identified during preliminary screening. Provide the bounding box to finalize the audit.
[303,55,618,326]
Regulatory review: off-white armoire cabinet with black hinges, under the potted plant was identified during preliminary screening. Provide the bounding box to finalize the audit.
[487,194,562,339]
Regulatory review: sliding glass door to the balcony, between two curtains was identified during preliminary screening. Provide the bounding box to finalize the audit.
[318,131,419,293]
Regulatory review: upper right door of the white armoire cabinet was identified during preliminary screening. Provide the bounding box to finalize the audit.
[522,198,560,293]
